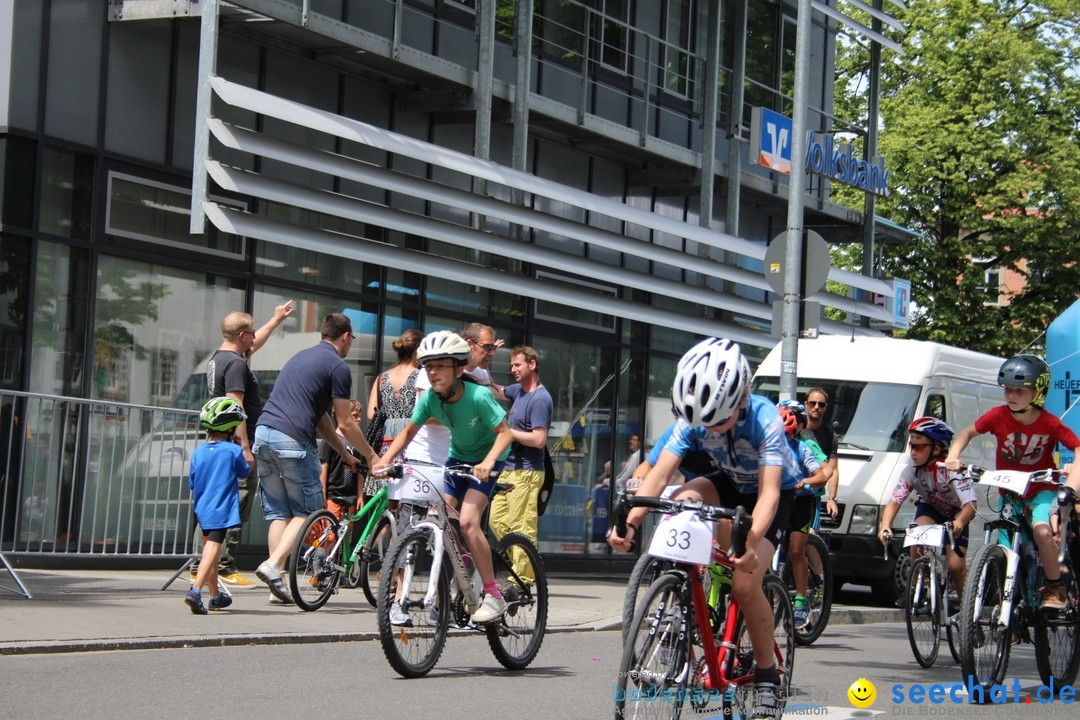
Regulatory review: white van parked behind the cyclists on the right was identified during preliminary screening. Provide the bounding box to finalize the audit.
[754,336,1003,602]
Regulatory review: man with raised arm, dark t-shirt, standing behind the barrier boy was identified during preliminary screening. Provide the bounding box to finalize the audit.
[191,300,293,587]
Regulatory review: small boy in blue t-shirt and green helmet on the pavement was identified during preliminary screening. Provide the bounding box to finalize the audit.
[184,397,252,615]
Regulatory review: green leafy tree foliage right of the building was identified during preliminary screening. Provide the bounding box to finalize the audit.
[836,0,1080,355]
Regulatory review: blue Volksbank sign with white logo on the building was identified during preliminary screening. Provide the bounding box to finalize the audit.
[750,108,890,196]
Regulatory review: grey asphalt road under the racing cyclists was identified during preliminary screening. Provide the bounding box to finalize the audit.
[0,623,1076,720]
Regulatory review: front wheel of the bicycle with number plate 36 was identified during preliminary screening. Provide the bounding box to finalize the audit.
[376,528,450,678]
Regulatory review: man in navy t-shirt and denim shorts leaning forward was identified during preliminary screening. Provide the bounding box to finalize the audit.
[252,313,379,604]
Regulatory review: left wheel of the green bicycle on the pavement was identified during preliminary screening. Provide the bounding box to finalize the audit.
[288,510,343,611]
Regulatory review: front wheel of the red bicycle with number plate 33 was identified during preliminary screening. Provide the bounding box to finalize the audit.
[615,572,693,720]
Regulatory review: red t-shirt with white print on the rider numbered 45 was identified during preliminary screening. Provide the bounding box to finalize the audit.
[975,405,1080,500]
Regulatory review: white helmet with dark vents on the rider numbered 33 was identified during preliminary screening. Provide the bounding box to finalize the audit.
[672,338,750,427]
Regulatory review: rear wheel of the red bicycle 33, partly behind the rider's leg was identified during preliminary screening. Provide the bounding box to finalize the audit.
[723,572,795,718]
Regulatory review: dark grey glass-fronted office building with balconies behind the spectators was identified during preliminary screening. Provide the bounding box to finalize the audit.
[0,0,894,566]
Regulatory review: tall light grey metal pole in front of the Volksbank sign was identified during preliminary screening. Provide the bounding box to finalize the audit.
[780,0,810,399]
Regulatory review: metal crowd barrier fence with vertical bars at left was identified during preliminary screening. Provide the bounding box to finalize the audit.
[0,391,202,558]
